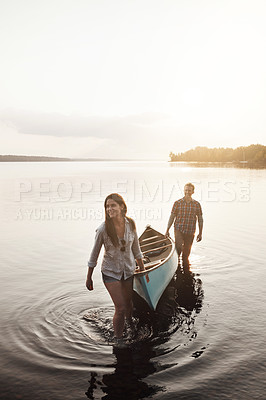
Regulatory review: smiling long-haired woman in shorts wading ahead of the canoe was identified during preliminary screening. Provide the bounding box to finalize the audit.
[86,193,144,339]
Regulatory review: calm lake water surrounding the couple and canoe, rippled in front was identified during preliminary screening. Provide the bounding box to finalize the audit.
[0,162,266,400]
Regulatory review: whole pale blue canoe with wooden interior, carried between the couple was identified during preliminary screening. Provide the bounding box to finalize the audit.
[133,225,177,310]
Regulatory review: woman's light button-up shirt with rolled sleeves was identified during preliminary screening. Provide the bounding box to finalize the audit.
[88,218,143,279]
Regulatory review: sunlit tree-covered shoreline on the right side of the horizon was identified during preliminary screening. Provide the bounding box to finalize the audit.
[169,144,266,164]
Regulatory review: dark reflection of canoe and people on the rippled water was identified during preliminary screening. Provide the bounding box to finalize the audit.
[86,268,203,400]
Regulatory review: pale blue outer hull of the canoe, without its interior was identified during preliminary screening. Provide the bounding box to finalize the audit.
[134,227,178,310]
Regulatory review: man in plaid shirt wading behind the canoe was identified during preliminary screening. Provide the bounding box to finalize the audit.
[165,183,203,271]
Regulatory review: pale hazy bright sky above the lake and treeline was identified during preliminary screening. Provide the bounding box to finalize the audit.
[0,0,266,160]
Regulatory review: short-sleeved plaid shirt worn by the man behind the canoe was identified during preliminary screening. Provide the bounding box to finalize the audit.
[171,197,202,235]
